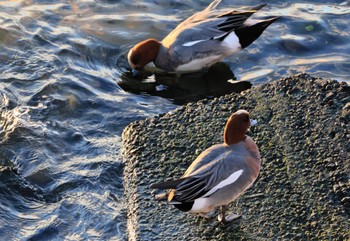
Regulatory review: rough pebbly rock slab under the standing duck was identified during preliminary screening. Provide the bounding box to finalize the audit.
[123,74,350,240]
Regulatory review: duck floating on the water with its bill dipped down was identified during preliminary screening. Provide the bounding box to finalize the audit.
[127,0,278,73]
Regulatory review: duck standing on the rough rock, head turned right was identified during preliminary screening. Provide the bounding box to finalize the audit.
[150,110,261,223]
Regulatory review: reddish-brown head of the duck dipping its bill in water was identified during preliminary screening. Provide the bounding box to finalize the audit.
[128,39,161,69]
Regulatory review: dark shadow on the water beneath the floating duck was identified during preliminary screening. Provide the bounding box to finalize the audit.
[118,63,252,105]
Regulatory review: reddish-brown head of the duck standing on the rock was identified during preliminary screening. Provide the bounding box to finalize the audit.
[224,110,256,145]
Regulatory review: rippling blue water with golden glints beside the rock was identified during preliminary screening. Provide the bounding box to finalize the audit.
[0,0,350,240]
